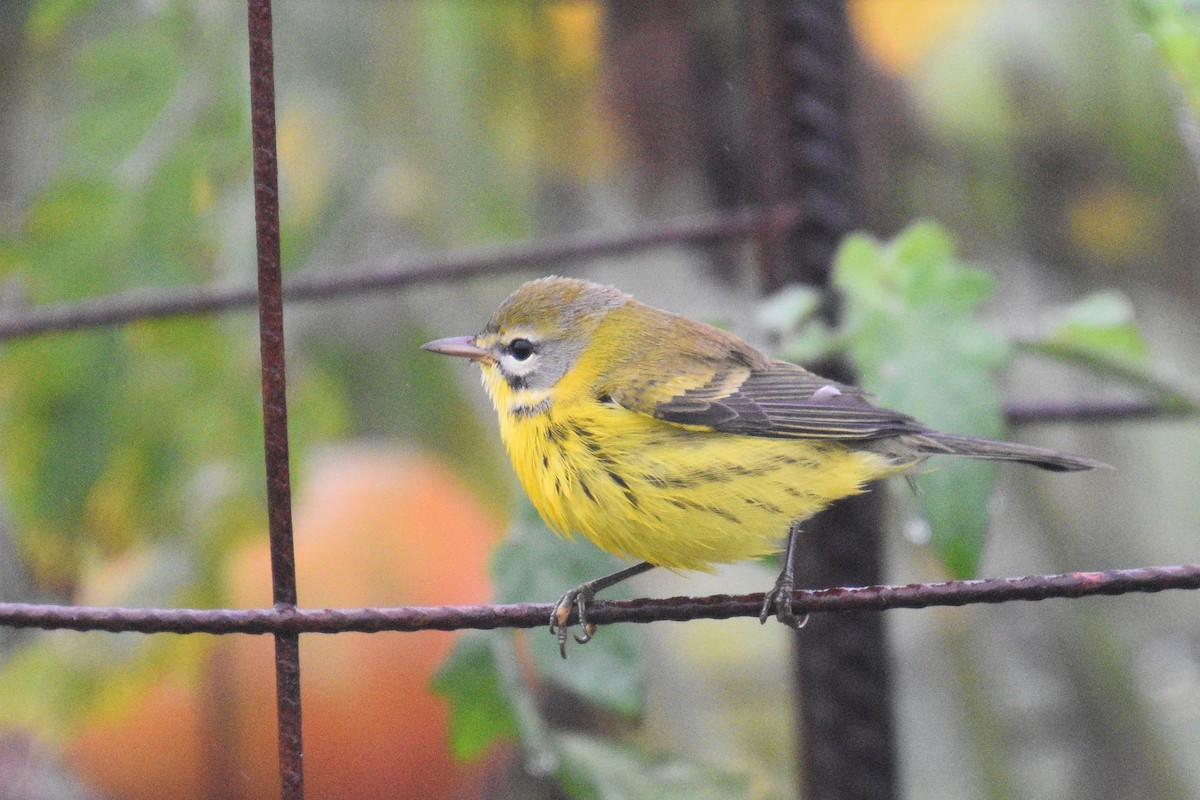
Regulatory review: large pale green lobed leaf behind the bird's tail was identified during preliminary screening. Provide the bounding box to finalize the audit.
[833,222,1009,577]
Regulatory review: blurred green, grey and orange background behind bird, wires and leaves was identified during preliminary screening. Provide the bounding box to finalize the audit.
[0,0,1200,800]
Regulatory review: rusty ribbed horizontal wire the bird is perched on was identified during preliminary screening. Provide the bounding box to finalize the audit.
[0,564,1200,634]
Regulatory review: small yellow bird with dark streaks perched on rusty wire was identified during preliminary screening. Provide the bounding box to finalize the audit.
[422,276,1104,657]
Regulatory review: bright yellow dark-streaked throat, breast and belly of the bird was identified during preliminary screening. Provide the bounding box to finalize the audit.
[484,366,895,570]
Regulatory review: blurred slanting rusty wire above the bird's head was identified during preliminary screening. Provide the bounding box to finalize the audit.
[0,206,799,341]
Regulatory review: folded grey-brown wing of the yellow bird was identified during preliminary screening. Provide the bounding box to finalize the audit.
[611,360,925,439]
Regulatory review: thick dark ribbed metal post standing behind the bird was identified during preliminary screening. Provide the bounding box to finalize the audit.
[758,0,898,800]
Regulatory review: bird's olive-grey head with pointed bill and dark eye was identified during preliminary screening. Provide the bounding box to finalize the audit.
[421,276,631,391]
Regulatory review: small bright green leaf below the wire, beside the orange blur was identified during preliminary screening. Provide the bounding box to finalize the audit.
[432,631,517,760]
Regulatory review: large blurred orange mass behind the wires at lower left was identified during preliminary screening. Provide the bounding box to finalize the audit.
[68,450,500,800]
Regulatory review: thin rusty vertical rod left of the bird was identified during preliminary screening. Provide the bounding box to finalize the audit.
[248,0,304,800]
